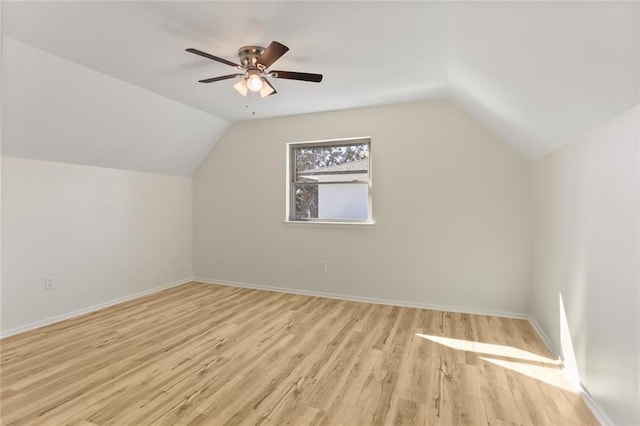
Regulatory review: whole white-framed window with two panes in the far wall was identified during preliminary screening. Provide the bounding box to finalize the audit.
[287,138,372,223]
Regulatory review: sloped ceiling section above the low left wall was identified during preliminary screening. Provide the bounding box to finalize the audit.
[2,37,229,176]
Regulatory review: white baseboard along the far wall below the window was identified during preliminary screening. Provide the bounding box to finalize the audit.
[193,277,529,320]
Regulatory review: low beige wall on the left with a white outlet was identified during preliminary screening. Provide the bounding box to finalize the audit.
[2,157,193,334]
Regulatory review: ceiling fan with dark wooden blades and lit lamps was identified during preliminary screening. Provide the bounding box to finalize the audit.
[186,41,322,98]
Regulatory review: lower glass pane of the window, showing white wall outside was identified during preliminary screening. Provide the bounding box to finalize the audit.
[294,183,369,220]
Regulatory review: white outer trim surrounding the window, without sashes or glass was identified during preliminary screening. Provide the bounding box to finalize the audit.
[282,136,375,228]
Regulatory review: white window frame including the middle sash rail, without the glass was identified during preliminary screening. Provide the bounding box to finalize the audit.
[284,136,374,226]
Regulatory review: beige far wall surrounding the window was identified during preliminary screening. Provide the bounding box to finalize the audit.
[194,100,529,313]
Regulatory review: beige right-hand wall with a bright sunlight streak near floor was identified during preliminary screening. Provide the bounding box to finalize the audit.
[531,107,640,425]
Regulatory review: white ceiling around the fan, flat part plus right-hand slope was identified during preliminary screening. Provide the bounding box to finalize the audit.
[3,1,640,163]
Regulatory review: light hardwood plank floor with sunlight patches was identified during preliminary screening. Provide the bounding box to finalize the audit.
[0,283,597,426]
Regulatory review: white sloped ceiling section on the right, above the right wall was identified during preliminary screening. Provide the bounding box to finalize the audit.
[448,2,640,158]
